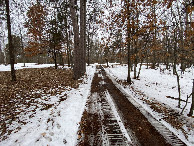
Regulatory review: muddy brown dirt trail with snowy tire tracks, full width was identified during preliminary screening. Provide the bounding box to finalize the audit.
[78,66,186,146]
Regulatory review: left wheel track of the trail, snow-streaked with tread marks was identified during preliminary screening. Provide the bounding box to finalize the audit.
[78,68,131,146]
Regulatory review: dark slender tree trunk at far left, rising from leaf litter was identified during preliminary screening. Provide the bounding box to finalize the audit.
[5,0,16,81]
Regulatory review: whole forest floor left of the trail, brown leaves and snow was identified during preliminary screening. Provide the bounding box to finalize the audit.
[0,64,95,146]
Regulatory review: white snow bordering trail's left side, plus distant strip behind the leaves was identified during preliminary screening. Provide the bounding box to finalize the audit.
[0,64,96,146]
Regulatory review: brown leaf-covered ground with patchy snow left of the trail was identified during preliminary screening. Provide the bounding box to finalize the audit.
[0,67,81,141]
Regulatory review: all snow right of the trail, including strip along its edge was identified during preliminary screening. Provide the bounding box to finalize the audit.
[105,65,194,145]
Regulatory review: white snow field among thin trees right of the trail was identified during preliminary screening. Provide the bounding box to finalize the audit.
[107,66,194,115]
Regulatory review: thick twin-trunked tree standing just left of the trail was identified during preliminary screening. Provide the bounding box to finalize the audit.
[70,0,86,79]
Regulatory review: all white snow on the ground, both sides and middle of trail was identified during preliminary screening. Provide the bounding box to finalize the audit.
[0,63,194,146]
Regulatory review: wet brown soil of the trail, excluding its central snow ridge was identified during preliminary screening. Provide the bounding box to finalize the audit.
[78,66,184,146]
